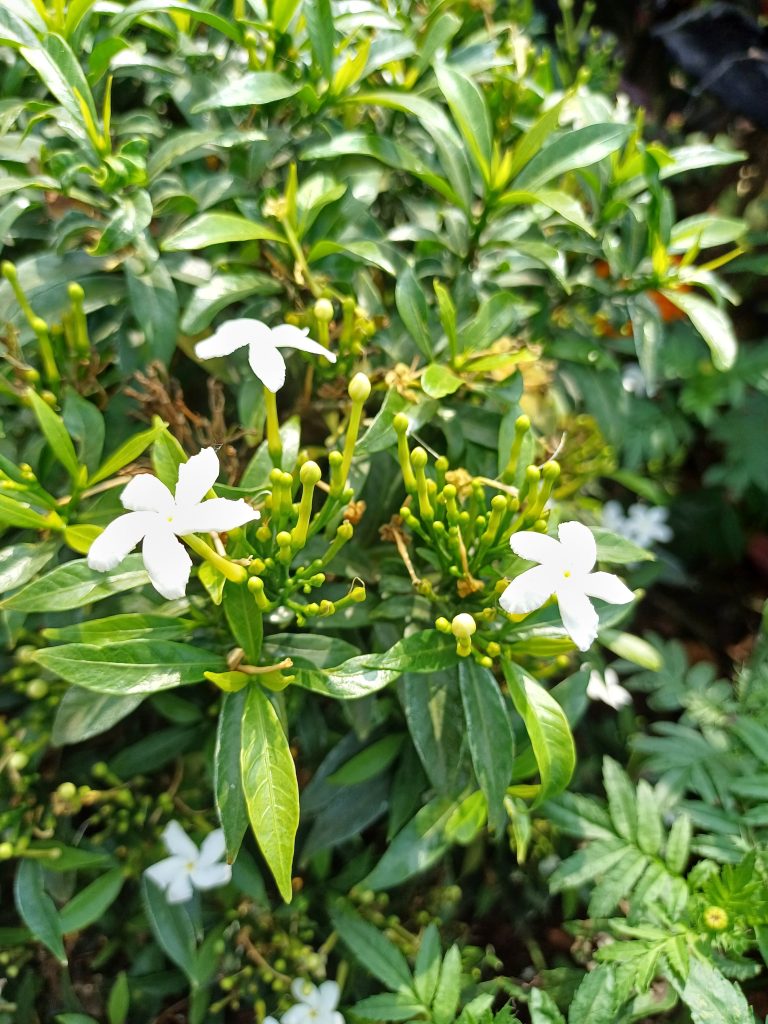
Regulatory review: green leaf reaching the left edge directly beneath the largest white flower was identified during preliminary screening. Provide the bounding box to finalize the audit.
[0,555,150,611]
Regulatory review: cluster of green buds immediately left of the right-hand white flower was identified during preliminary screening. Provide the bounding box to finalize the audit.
[393,413,560,668]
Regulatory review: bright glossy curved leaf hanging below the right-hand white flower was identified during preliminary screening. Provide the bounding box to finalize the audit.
[502,658,575,806]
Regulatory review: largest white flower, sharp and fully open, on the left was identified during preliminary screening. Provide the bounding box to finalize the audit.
[88,447,259,601]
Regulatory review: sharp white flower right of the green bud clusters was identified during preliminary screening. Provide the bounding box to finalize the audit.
[499,522,634,650]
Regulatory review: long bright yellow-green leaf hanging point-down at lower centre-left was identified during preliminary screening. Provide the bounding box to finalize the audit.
[241,684,299,903]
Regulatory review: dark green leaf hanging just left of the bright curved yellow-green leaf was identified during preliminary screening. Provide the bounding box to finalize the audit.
[459,657,515,835]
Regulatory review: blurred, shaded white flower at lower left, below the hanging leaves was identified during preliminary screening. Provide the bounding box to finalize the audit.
[144,821,232,903]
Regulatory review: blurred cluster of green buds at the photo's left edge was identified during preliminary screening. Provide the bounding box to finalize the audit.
[0,260,91,395]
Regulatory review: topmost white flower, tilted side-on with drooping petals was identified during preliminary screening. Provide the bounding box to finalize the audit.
[195,317,336,392]
